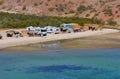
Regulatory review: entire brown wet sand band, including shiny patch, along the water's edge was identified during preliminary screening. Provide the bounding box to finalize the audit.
[2,32,120,51]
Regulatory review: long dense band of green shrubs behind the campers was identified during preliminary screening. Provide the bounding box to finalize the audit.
[0,12,101,28]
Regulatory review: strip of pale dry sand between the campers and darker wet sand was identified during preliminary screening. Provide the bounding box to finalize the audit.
[0,29,119,49]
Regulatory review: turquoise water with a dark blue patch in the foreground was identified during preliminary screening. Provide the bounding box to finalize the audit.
[0,49,120,79]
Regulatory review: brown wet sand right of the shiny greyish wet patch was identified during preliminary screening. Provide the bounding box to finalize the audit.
[62,32,120,49]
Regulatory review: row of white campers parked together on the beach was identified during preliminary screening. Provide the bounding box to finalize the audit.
[26,26,60,36]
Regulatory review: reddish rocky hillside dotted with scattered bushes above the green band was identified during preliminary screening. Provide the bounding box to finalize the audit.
[0,0,120,24]
